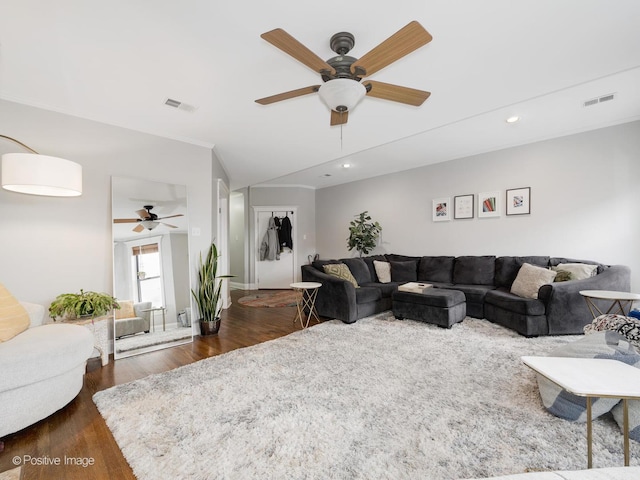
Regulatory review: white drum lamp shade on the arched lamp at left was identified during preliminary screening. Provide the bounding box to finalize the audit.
[2,153,82,197]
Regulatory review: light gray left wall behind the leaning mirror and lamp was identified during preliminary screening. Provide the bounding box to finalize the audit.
[0,100,222,306]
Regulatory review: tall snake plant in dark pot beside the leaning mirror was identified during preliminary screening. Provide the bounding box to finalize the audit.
[191,243,233,336]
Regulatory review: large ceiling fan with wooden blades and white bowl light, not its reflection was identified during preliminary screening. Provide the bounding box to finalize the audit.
[256,21,433,125]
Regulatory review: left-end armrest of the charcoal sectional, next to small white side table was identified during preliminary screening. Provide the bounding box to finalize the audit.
[302,265,358,323]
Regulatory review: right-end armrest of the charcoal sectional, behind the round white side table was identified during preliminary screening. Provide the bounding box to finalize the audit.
[538,265,631,335]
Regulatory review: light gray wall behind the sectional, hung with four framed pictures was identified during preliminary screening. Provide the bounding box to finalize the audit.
[316,122,640,292]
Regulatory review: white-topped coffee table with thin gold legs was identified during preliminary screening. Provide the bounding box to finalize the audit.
[522,357,640,468]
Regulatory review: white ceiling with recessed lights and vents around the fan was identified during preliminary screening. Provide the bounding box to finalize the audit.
[0,0,640,189]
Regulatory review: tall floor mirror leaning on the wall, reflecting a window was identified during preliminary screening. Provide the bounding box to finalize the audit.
[111,177,193,359]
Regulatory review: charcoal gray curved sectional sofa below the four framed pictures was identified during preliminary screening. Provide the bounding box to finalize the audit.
[302,254,631,336]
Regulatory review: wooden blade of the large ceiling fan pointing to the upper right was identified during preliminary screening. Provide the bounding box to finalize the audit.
[351,20,433,76]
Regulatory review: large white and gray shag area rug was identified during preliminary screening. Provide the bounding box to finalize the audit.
[94,313,640,480]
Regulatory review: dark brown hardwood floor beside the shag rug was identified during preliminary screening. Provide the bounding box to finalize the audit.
[0,290,316,480]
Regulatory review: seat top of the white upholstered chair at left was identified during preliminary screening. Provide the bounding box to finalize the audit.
[0,323,93,391]
